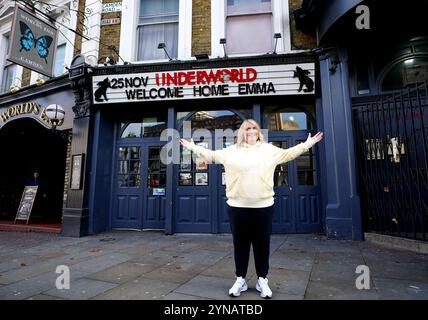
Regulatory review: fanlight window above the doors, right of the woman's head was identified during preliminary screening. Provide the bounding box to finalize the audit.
[263,105,314,131]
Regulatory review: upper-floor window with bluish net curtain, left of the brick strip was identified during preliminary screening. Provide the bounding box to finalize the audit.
[138,0,179,60]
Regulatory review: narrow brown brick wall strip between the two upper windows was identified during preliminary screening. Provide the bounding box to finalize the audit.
[192,0,211,56]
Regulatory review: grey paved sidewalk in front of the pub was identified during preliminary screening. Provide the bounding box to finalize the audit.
[0,231,428,300]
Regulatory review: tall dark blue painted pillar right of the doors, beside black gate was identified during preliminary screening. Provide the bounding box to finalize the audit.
[320,50,362,240]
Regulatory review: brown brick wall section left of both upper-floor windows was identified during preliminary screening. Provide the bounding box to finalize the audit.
[98,0,122,63]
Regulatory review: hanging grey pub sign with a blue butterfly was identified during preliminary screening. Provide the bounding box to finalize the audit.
[7,5,58,77]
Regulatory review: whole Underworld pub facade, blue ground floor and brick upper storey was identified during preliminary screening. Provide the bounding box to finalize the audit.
[2,0,368,240]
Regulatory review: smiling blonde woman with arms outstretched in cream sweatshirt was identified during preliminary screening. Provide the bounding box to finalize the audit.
[180,119,323,299]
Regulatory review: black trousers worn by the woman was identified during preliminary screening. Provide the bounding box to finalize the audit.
[228,206,273,278]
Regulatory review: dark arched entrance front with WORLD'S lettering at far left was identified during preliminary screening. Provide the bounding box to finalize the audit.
[0,78,74,232]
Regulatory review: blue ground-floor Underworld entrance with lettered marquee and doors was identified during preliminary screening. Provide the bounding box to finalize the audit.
[65,54,323,233]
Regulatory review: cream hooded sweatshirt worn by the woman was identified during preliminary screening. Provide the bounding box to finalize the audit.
[189,142,309,208]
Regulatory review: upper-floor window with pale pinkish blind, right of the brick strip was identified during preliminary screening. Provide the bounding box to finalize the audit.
[226,0,273,54]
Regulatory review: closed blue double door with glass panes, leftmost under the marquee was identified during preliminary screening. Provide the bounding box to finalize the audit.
[111,141,167,229]
